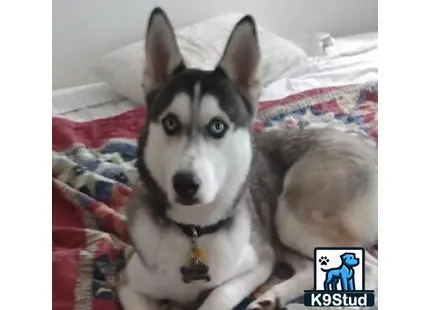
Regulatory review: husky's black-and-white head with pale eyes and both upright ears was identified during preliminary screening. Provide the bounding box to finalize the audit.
[139,8,261,223]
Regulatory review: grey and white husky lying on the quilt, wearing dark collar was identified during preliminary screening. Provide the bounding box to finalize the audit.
[118,8,378,310]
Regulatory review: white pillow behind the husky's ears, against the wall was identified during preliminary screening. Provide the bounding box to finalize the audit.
[94,13,307,103]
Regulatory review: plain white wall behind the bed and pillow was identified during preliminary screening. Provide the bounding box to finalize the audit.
[52,0,378,89]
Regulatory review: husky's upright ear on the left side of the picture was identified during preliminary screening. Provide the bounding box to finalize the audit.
[142,8,185,94]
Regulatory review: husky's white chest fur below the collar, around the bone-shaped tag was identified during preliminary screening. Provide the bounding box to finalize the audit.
[126,208,258,302]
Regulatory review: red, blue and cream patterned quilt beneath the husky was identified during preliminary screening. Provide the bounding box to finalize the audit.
[52,84,378,310]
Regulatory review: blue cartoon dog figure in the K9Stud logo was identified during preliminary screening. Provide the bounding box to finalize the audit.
[321,253,360,291]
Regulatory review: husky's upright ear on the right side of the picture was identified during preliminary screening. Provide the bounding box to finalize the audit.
[218,15,261,101]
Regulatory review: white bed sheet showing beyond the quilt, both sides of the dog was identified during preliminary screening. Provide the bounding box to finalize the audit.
[52,34,378,121]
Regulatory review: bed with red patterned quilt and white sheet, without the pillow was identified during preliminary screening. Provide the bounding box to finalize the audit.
[52,27,378,310]
